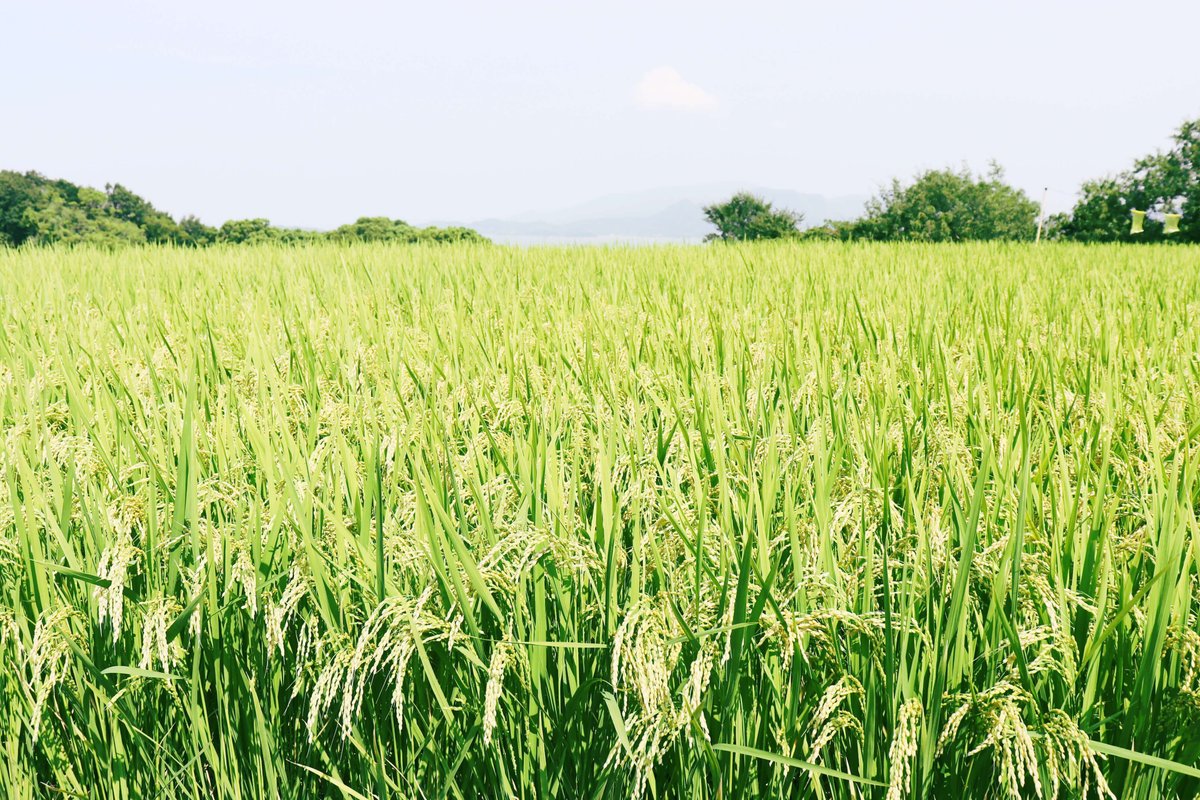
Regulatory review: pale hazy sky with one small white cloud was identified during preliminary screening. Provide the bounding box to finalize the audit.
[0,0,1200,227]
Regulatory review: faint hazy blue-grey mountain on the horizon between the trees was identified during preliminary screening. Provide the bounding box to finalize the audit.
[439,184,866,243]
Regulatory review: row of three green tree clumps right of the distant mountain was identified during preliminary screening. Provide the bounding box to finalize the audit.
[704,113,1200,242]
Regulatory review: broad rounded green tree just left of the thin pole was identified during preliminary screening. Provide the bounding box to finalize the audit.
[841,163,1038,242]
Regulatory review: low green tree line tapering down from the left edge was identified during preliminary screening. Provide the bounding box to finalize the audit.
[0,170,487,247]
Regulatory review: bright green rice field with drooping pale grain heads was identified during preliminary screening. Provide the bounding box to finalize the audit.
[0,243,1200,800]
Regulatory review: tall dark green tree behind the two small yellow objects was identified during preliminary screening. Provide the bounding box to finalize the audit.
[1062,120,1200,243]
